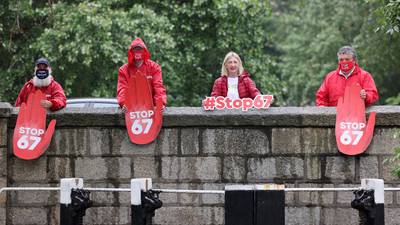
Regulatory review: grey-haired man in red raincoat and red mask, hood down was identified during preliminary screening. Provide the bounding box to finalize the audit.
[315,46,379,106]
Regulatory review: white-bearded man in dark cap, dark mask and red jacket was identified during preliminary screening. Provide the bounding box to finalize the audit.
[15,58,67,111]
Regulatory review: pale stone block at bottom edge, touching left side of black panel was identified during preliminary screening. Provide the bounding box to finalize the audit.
[154,207,224,225]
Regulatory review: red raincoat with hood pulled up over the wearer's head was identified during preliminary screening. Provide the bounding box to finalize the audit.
[117,38,167,107]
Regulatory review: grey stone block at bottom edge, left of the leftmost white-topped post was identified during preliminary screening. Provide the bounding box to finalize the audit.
[7,207,50,225]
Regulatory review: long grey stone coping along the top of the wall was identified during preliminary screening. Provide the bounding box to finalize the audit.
[0,103,400,127]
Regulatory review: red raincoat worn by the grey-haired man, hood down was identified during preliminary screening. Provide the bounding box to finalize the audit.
[316,64,379,106]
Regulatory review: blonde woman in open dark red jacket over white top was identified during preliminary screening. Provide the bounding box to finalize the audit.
[211,52,260,100]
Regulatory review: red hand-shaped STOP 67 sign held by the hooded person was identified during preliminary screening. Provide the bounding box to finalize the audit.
[125,73,163,144]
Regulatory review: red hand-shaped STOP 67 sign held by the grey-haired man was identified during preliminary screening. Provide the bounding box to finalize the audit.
[335,85,376,155]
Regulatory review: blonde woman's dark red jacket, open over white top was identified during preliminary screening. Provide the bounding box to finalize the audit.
[211,71,260,99]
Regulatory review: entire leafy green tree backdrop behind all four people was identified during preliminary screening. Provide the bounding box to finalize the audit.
[0,0,400,106]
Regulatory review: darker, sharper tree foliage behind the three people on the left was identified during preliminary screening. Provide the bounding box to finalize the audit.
[0,0,282,105]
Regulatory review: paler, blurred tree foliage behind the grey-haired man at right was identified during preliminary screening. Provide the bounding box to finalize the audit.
[273,0,400,105]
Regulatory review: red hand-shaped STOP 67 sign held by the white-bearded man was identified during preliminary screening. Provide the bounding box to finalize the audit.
[13,90,56,160]
